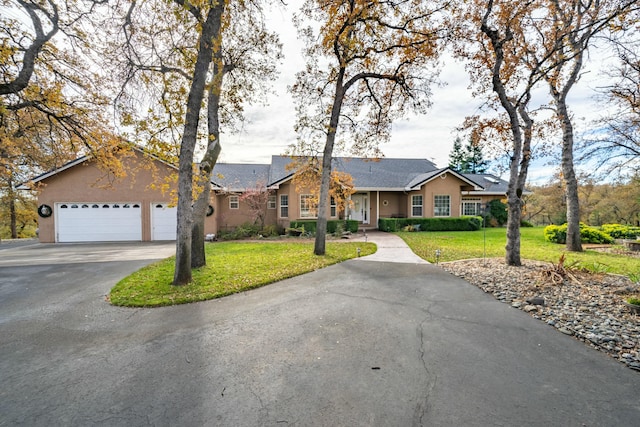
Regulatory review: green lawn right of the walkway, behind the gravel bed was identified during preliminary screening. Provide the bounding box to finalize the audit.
[396,227,640,280]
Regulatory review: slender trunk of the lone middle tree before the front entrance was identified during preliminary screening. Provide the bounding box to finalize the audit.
[313,72,345,255]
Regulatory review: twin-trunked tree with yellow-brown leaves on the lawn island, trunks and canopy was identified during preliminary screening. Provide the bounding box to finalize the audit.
[112,0,280,285]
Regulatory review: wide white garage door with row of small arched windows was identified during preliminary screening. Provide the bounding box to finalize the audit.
[55,203,142,242]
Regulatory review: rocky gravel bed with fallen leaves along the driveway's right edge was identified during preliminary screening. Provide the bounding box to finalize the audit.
[439,258,640,372]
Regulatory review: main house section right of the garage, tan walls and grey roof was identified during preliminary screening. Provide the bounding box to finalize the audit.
[212,156,507,229]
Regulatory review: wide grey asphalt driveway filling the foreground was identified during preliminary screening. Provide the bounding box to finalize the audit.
[0,244,640,426]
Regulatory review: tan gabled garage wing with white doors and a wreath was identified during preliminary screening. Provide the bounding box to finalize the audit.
[19,148,216,243]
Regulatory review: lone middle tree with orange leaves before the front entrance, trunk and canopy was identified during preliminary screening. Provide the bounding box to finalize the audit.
[291,0,446,255]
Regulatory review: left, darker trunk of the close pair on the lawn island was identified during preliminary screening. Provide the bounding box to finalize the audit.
[173,2,224,285]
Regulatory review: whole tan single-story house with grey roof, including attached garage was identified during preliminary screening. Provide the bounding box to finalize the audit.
[20,149,507,242]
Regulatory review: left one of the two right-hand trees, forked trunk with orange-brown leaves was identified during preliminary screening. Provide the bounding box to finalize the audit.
[456,0,541,266]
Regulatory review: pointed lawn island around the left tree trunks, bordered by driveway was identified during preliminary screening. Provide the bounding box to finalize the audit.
[109,242,376,307]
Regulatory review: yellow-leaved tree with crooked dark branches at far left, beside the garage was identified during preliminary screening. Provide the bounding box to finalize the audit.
[0,0,122,237]
